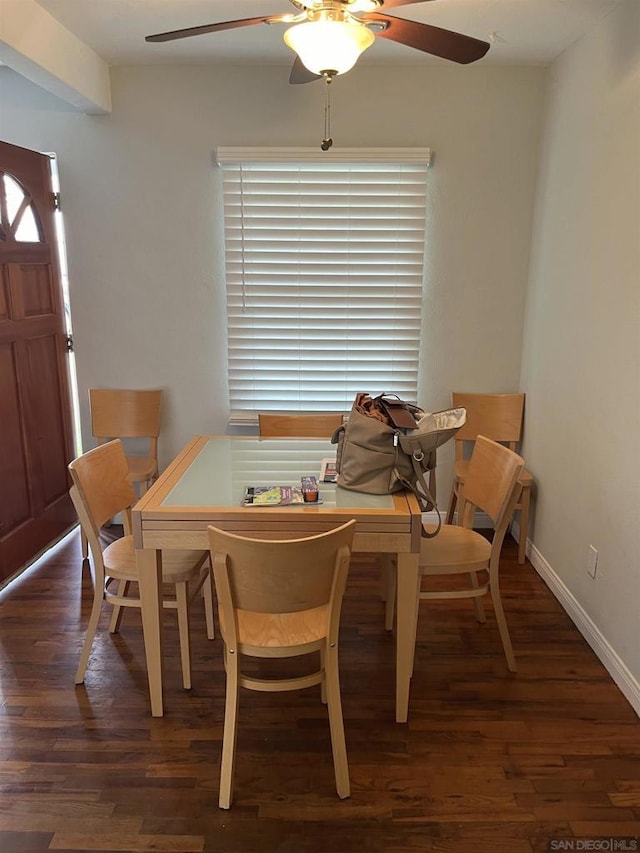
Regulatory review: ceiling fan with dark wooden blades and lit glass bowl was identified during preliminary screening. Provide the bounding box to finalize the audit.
[145,0,489,83]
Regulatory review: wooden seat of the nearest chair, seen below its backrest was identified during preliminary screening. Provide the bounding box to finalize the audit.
[219,605,327,651]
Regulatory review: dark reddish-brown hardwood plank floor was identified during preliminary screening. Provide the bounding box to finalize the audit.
[0,533,640,853]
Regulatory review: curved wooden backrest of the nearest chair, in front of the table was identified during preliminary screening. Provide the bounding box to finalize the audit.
[208,519,356,645]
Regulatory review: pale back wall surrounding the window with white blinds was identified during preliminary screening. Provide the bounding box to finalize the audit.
[0,63,544,482]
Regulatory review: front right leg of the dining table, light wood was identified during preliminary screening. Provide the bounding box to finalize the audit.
[396,553,420,723]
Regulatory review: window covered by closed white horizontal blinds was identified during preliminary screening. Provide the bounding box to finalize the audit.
[218,149,429,423]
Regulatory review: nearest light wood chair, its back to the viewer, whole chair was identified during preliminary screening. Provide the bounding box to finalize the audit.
[208,520,356,809]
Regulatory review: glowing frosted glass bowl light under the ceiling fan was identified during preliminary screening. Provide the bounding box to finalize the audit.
[284,20,375,75]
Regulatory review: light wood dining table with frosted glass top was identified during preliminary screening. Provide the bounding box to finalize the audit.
[132,435,422,723]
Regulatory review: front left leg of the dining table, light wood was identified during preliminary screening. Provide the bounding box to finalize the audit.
[136,549,163,717]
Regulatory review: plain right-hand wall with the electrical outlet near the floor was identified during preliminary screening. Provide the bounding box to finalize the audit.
[522,0,640,700]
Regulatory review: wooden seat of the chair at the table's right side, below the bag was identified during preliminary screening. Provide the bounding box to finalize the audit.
[420,524,491,574]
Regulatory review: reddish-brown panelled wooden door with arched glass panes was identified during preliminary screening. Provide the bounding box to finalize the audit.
[0,142,76,583]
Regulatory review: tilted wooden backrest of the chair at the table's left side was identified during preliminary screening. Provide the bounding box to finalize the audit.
[69,439,137,535]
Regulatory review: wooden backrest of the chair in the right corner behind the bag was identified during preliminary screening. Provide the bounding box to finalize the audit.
[451,391,524,459]
